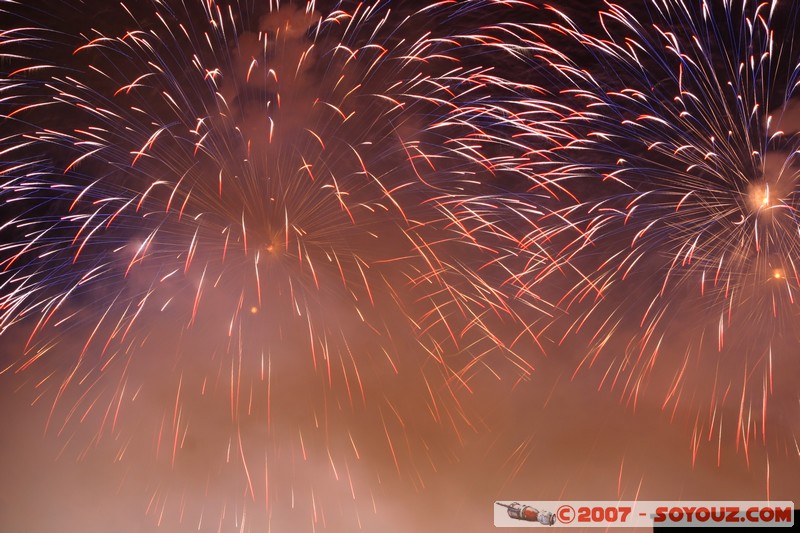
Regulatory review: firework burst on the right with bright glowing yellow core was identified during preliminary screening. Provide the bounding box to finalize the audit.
[522,0,800,466]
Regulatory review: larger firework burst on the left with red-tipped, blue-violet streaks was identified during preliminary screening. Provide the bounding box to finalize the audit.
[0,1,549,529]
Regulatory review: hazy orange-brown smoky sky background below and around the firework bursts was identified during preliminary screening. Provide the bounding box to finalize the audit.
[0,2,800,533]
